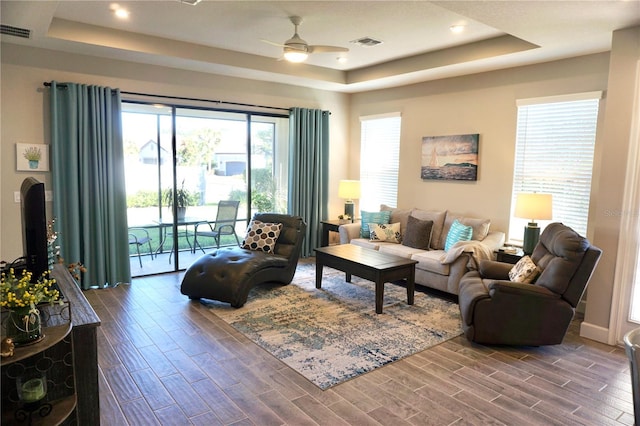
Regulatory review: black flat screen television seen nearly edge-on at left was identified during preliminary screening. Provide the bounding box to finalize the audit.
[20,177,49,281]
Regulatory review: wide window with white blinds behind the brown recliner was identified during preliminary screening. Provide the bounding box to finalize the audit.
[509,92,601,240]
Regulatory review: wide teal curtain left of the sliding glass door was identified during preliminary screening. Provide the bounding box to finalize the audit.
[50,81,131,289]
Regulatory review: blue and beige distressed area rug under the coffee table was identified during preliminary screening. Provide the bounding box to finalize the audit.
[207,263,462,389]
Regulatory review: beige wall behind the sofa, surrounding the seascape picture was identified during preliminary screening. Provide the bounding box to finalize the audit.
[350,54,609,238]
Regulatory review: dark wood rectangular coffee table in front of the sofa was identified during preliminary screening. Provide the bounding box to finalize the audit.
[315,244,418,314]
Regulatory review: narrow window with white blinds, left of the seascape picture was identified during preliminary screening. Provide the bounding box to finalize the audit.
[357,113,400,211]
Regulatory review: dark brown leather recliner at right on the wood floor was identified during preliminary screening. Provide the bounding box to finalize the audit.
[458,223,602,346]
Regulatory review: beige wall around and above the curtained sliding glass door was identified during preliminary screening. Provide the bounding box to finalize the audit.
[0,43,348,261]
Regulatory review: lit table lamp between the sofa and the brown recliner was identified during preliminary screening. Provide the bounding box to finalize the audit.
[515,193,553,254]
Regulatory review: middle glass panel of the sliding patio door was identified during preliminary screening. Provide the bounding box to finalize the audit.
[176,108,248,269]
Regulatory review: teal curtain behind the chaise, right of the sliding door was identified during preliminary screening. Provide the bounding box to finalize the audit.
[288,108,330,257]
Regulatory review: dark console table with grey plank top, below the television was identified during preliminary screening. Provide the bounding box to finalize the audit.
[51,264,100,425]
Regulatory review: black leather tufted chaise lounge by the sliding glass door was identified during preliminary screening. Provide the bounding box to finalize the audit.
[180,213,307,308]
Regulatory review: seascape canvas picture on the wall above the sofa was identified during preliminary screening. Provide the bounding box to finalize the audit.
[420,133,480,180]
